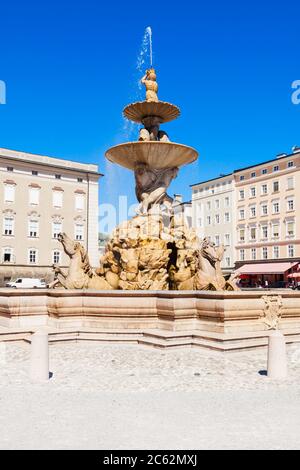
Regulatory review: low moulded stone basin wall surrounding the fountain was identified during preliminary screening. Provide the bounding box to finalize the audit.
[0,289,300,350]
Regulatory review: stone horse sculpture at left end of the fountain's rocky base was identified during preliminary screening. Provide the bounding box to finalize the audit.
[49,233,113,290]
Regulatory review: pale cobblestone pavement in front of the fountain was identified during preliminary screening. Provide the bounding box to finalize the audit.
[0,342,300,449]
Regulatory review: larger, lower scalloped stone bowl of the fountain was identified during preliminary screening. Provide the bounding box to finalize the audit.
[105,141,198,170]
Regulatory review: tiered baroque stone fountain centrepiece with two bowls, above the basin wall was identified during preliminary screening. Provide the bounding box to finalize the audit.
[52,68,237,290]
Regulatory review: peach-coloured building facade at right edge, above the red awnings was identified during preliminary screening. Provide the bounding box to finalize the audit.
[234,149,300,266]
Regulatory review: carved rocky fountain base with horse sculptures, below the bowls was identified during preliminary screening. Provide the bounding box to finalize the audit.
[52,212,237,290]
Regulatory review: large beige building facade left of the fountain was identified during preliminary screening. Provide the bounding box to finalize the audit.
[0,148,101,285]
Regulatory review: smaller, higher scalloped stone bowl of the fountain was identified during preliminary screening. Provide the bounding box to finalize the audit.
[123,101,180,123]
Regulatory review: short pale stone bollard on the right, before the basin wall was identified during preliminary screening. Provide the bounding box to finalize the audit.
[268,330,287,379]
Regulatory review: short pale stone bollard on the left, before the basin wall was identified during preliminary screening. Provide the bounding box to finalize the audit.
[30,330,49,382]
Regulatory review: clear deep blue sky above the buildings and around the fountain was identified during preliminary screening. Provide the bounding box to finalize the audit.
[0,0,300,220]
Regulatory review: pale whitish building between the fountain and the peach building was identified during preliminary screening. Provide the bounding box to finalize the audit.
[191,174,236,273]
